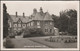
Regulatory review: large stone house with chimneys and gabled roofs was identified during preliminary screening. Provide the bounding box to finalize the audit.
[9,8,58,34]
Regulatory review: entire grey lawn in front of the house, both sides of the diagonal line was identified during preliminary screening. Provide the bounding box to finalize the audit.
[11,36,77,48]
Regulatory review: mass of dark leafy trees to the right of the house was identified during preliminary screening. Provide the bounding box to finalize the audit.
[52,9,77,35]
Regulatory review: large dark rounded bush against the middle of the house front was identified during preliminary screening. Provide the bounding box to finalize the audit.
[23,28,44,38]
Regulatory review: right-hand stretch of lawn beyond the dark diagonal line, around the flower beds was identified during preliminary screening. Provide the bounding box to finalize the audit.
[29,37,77,48]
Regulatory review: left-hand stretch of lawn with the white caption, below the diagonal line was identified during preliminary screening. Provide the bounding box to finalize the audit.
[11,38,47,48]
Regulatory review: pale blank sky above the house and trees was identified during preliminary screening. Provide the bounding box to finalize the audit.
[2,1,79,16]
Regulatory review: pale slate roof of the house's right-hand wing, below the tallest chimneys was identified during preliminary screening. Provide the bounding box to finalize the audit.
[32,12,53,21]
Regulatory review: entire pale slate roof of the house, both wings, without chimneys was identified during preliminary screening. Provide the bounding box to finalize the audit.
[10,8,53,23]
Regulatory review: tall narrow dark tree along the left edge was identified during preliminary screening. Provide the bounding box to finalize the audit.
[3,4,9,38]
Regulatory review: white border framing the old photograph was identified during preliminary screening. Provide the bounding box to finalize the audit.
[1,1,79,50]
